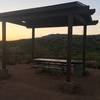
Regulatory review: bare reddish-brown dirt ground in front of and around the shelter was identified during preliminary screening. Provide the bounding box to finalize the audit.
[0,64,100,100]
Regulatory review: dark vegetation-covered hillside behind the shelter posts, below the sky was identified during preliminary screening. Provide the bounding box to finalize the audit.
[0,34,100,67]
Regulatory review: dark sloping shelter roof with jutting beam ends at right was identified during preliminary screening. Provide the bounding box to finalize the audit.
[0,1,98,28]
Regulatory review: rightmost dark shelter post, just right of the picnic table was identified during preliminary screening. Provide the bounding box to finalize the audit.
[83,25,87,75]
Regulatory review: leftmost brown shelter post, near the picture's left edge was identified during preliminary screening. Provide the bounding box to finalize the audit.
[2,21,6,70]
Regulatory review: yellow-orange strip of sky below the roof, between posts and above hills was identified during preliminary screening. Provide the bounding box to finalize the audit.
[0,23,100,41]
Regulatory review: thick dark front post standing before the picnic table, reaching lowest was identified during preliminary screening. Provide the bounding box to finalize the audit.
[67,15,73,82]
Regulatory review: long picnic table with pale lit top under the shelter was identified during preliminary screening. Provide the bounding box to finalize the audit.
[33,58,82,71]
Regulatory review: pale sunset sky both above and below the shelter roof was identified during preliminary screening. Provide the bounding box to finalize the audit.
[0,0,100,41]
